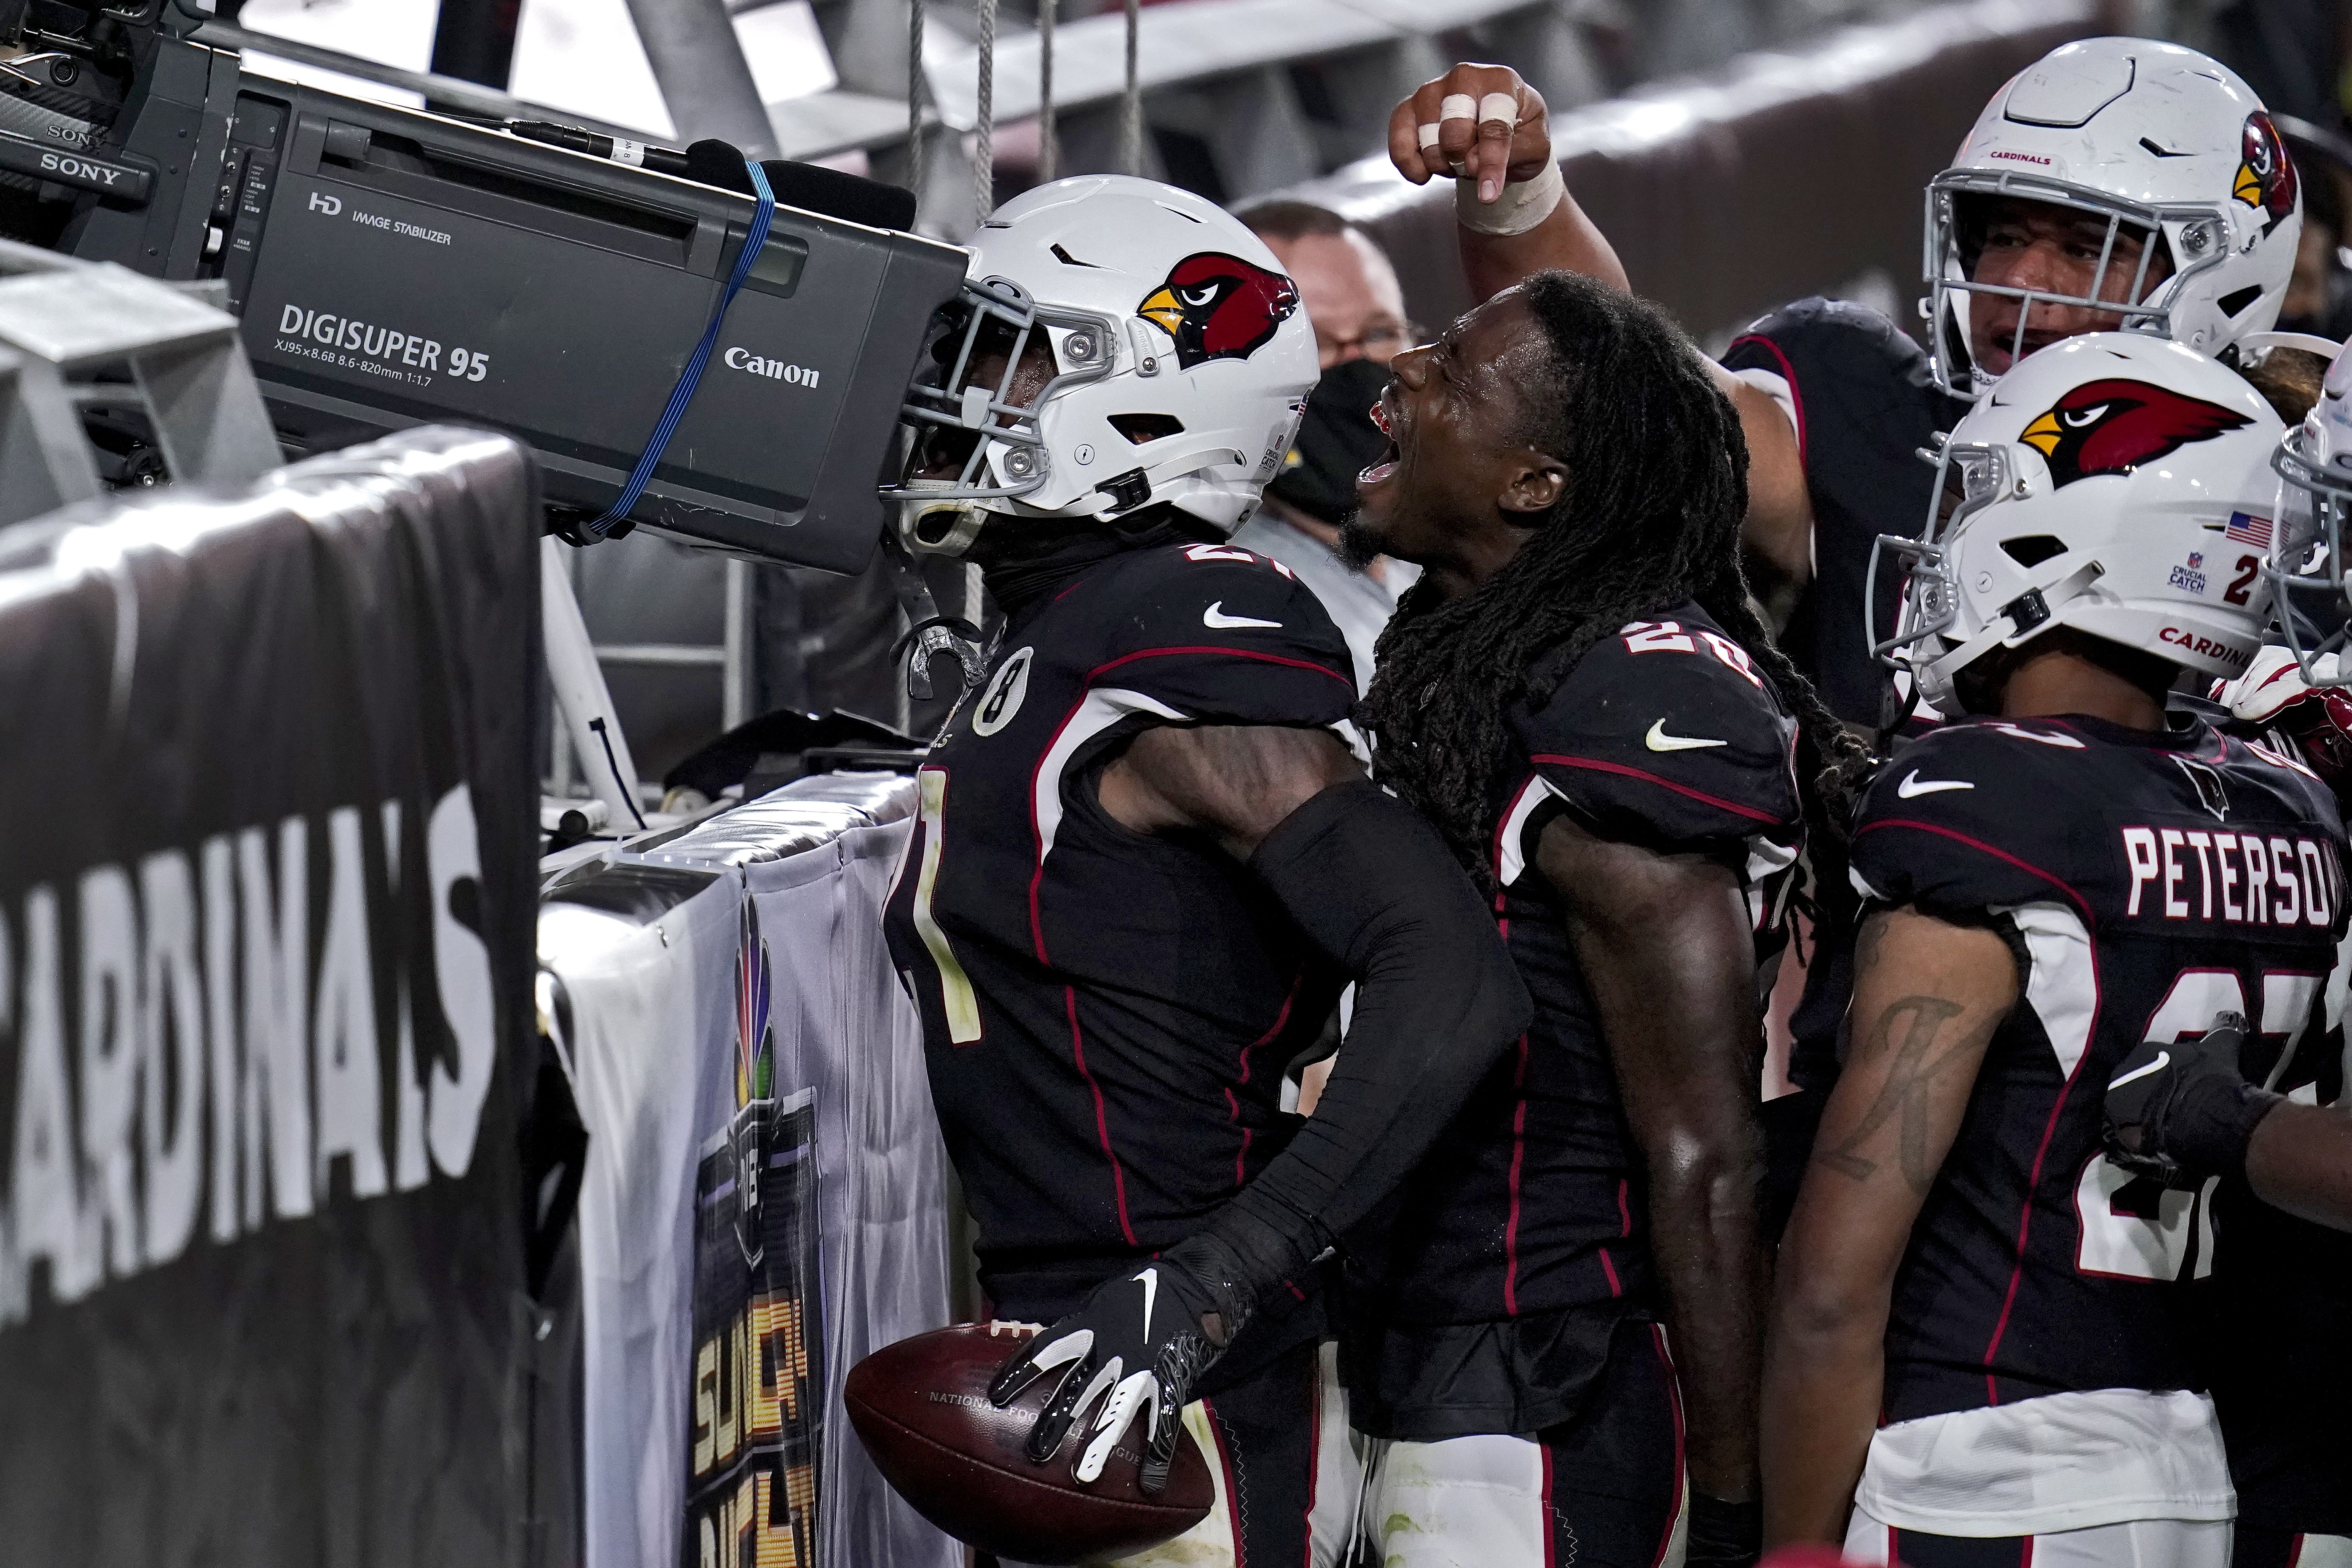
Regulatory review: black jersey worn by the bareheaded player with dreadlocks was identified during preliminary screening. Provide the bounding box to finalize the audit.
[1348,604,1799,1439]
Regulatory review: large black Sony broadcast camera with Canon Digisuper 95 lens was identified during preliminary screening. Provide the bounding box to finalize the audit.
[0,0,964,571]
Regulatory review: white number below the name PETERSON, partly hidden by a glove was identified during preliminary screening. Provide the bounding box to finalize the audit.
[2074,968,2319,1279]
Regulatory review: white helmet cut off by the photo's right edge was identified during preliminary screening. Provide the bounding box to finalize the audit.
[2270,348,2352,686]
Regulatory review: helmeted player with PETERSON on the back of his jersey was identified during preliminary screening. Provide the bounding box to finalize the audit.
[1764,334,2343,1568]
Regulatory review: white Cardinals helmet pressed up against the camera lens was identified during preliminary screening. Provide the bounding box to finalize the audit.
[882,174,1319,555]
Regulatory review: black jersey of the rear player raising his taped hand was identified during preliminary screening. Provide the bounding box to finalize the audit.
[1722,298,1968,729]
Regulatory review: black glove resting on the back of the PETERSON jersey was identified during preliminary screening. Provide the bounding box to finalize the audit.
[2100,1013,2279,1192]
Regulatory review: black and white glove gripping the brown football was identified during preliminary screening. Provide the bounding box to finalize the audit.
[988,1253,1235,1493]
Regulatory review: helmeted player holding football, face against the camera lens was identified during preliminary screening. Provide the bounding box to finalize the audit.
[887,176,1526,1568]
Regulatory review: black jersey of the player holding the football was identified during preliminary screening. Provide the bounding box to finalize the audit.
[884,545,1355,1321]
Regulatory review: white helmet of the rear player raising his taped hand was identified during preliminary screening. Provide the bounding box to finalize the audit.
[1926,38,2303,397]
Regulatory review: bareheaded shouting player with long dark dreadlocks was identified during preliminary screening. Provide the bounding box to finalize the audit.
[1341,273,1853,1568]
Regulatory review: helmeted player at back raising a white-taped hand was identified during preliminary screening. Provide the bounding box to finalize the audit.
[1388,38,2310,729]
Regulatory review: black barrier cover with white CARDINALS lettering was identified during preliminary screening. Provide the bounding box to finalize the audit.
[0,428,543,1568]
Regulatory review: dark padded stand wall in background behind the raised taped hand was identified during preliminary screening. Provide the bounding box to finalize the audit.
[1291,0,2105,338]
